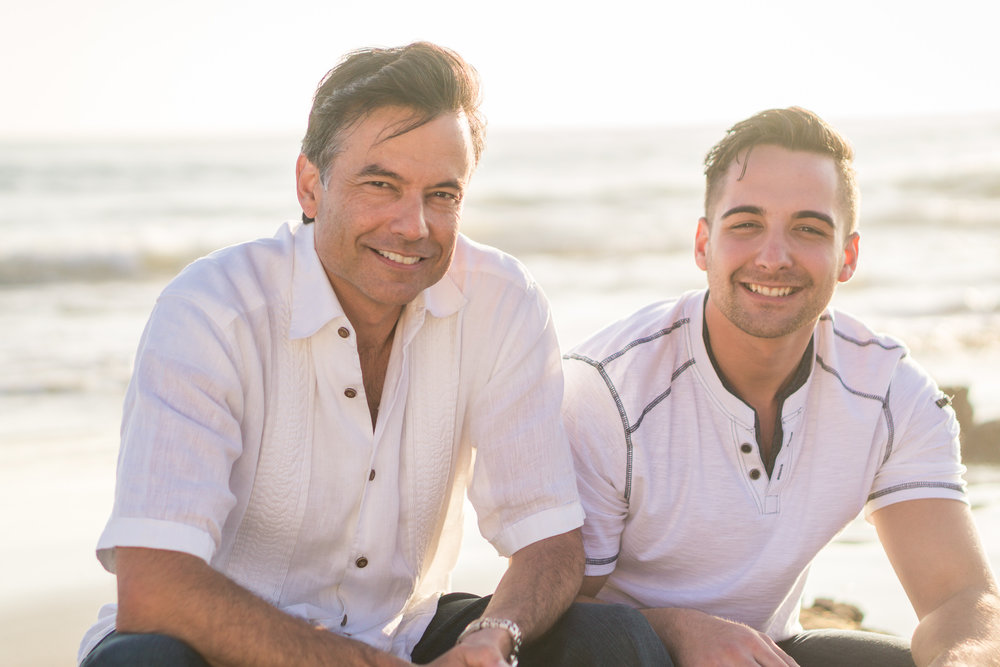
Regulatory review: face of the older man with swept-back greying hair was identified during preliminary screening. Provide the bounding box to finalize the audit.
[297,107,473,321]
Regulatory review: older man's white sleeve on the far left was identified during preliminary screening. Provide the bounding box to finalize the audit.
[98,296,243,571]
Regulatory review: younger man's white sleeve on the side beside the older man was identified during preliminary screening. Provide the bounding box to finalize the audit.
[562,358,628,577]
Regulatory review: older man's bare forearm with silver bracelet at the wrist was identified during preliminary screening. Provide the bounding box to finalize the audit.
[462,529,583,656]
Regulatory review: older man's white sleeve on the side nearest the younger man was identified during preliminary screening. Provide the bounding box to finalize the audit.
[467,283,583,556]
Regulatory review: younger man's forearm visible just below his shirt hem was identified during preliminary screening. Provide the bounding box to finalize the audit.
[642,609,798,667]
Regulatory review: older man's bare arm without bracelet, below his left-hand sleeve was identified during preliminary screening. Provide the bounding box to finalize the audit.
[111,548,408,667]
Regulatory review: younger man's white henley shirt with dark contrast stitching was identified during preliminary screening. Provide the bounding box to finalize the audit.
[563,291,965,641]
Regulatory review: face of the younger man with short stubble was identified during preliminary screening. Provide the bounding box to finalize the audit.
[695,145,858,338]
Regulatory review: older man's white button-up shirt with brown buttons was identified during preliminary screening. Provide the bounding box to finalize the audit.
[80,225,583,659]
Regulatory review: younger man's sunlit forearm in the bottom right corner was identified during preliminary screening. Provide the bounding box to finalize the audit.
[911,591,1000,667]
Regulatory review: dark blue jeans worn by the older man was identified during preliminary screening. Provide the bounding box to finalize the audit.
[81,593,673,667]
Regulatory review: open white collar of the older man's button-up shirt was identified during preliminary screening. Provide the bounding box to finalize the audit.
[289,223,466,340]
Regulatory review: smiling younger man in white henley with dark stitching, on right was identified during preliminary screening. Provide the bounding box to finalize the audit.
[563,108,1000,666]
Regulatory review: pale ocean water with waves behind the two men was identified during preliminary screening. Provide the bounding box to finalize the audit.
[0,115,1000,418]
